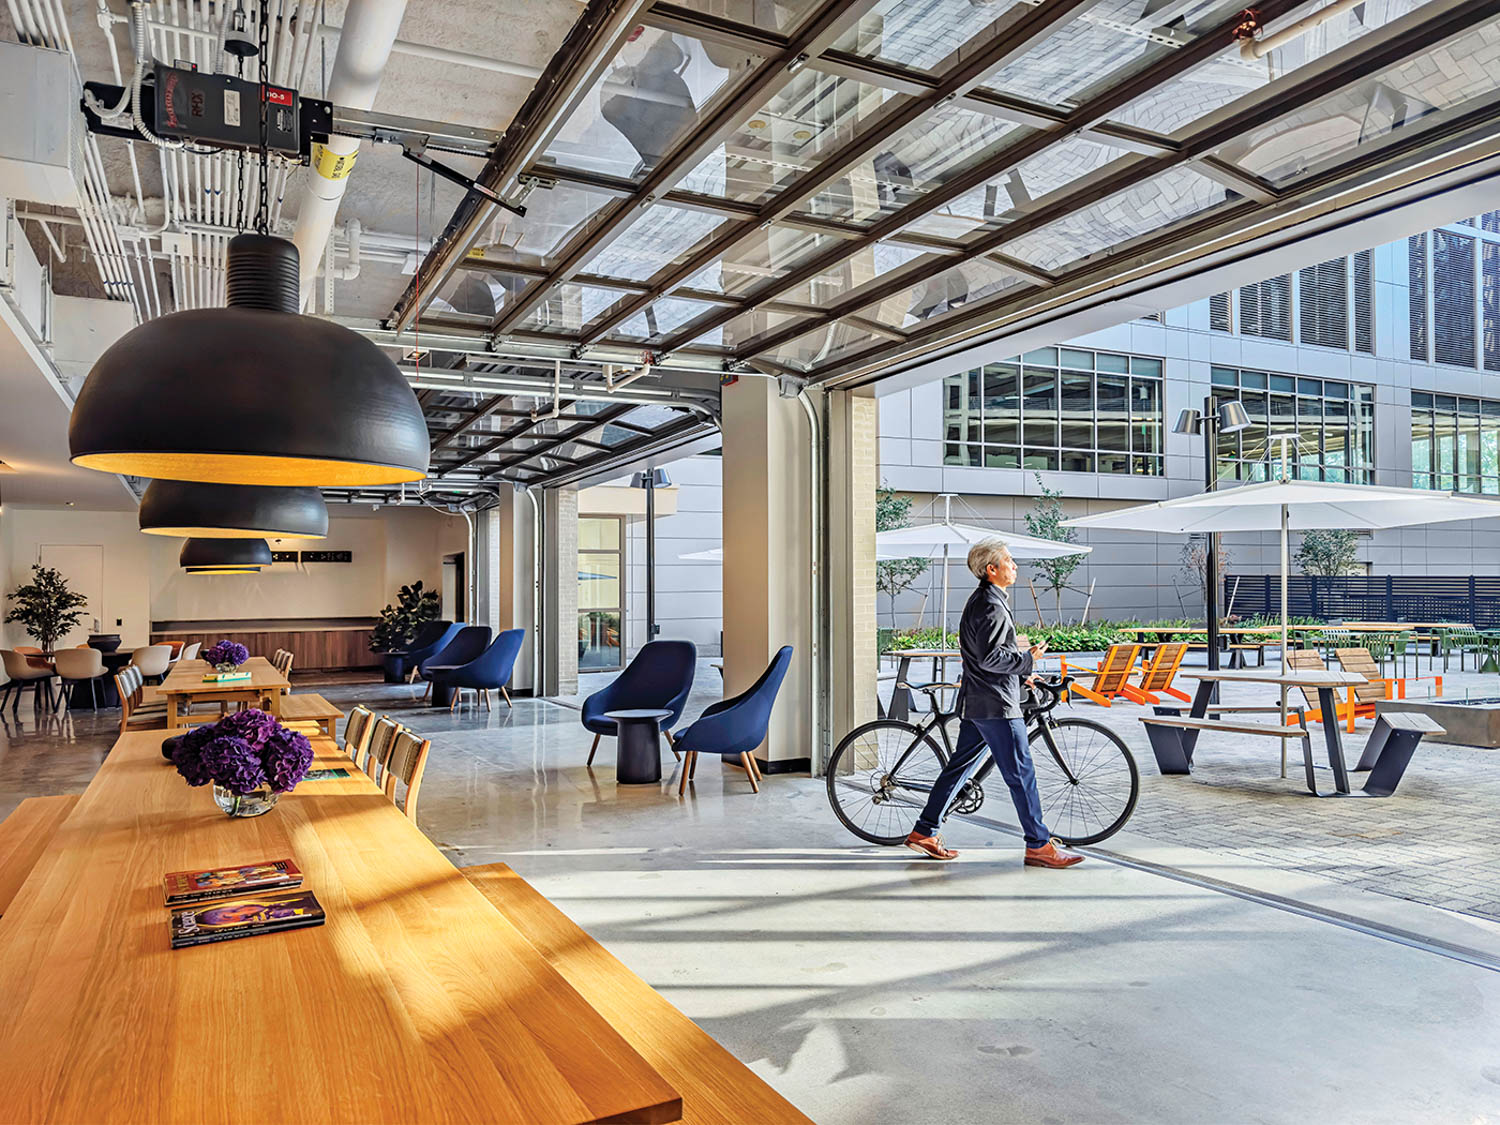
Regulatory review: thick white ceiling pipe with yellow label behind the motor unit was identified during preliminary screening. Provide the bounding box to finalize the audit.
[291,0,407,306]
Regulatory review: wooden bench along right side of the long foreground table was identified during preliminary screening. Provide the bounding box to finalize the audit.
[461,864,810,1125]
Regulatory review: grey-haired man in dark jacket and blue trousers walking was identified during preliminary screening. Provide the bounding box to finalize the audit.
[906,539,1083,867]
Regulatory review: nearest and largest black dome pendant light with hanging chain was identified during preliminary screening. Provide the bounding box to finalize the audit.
[68,3,429,486]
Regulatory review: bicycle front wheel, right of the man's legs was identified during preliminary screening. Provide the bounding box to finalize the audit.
[1031,719,1140,845]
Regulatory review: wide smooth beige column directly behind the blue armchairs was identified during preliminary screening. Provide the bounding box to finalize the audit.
[723,377,813,773]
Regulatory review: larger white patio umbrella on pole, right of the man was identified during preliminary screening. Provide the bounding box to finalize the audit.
[1064,435,1500,672]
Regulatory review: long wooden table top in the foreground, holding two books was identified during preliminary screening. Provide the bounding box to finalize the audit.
[0,731,681,1125]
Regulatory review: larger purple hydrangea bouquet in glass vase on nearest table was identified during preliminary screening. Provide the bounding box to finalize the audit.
[162,710,312,816]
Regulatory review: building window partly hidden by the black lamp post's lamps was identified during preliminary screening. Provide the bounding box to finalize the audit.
[1212,368,1376,485]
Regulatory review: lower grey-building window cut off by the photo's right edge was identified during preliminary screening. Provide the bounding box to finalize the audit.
[1412,390,1500,497]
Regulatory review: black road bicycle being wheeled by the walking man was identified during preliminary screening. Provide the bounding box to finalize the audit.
[828,677,1140,845]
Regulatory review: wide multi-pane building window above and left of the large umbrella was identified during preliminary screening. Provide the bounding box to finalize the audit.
[944,348,1163,477]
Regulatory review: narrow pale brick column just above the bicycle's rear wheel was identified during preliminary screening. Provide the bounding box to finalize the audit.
[828,392,881,747]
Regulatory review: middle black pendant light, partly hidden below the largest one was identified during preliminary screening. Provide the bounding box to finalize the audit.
[140,480,329,539]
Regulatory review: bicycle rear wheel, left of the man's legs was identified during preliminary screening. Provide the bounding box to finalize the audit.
[825,719,947,845]
